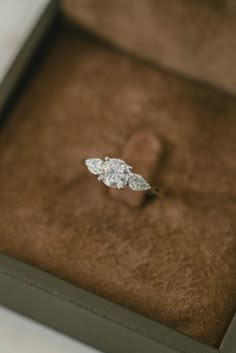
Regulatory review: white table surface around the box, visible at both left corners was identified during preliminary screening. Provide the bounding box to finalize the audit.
[0,0,100,353]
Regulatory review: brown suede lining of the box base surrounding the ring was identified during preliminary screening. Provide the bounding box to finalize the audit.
[0,24,236,345]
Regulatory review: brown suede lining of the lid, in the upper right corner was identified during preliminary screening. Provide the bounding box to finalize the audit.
[61,0,236,93]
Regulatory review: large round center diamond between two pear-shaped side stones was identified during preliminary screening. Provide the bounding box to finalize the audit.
[99,157,130,189]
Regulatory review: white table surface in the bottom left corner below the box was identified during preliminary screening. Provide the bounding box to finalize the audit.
[0,306,98,353]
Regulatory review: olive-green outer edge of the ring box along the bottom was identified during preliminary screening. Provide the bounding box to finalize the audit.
[0,254,236,353]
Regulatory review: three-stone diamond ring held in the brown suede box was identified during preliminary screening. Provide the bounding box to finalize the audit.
[84,157,158,192]
